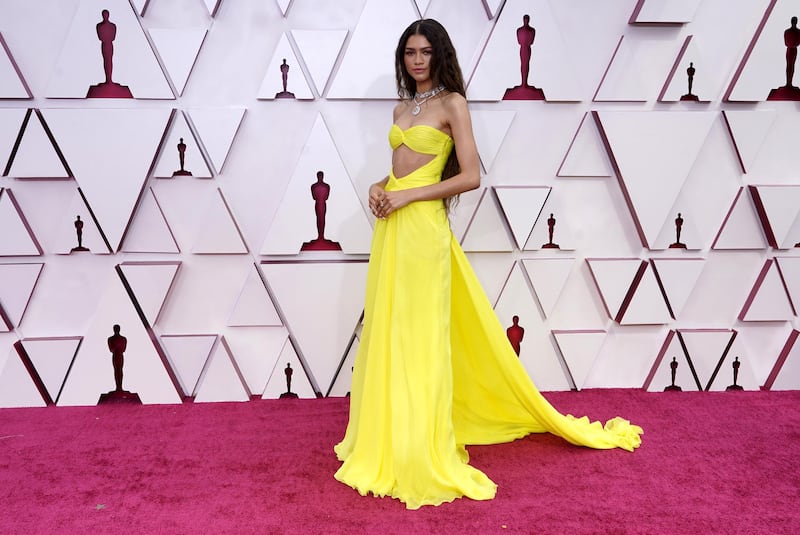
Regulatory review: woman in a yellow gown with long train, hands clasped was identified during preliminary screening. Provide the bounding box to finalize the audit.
[335,19,642,509]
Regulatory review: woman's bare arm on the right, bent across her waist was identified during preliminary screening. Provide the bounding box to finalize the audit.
[370,93,481,217]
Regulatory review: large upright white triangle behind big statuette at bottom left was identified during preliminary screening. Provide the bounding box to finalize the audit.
[58,273,181,406]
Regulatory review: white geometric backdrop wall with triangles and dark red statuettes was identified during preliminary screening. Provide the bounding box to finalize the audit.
[0,0,800,407]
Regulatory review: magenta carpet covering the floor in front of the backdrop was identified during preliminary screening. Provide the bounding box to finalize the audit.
[0,390,800,534]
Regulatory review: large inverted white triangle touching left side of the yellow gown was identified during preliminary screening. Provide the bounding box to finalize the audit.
[262,261,367,396]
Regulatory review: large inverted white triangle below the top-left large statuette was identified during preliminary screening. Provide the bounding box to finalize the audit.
[42,109,170,251]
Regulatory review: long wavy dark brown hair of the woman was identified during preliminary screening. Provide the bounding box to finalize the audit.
[394,19,467,210]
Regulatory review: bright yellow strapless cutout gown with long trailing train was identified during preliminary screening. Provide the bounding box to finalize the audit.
[334,125,642,509]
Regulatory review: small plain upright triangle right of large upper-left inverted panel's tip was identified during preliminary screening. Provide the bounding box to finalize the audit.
[121,188,181,253]
